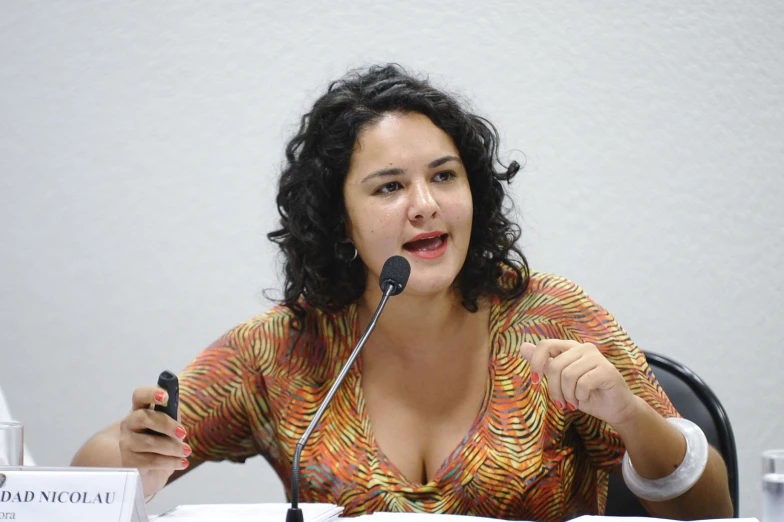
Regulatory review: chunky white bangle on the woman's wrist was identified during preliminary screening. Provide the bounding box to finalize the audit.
[623,417,708,502]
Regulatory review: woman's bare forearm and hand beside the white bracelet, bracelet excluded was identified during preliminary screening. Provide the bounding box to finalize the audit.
[521,339,733,519]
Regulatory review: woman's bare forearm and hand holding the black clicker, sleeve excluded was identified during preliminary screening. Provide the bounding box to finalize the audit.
[71,386,198,496]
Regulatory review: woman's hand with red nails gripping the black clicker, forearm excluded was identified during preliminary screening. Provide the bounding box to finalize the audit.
[120,386,191,496]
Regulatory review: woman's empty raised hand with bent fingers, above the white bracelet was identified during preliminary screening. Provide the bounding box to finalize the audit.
[520,339,637,426]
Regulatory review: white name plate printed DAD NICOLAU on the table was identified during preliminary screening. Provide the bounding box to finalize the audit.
[0,467,149,522]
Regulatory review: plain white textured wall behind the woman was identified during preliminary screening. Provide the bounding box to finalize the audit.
[0,0,784,516]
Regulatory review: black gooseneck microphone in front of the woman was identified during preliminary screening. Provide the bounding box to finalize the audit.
[286,256,411,522]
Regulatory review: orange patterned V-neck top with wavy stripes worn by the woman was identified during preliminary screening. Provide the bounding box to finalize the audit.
[180,272,677,520]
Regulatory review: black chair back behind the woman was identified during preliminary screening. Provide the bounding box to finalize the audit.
[606,353,738,518]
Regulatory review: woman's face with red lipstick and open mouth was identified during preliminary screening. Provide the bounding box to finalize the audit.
[343,113,474,295]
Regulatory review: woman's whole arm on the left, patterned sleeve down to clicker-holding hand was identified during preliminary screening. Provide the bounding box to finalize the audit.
[72,309,282,496]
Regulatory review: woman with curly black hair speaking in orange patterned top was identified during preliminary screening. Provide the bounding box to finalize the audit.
[74,66,732,520]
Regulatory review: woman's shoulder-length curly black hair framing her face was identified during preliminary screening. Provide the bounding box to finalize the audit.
[267,64,529,320]
